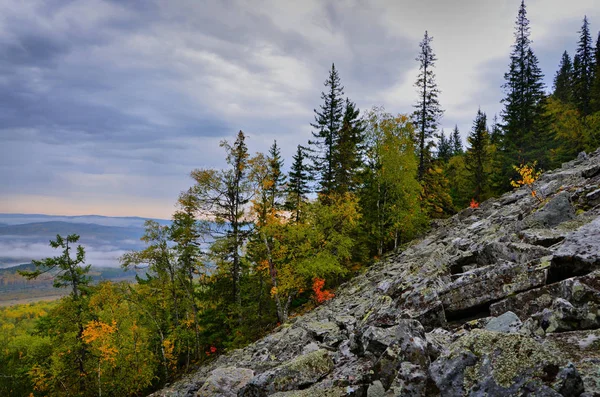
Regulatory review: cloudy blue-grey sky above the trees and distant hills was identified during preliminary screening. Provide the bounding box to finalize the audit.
[0,0,600,218]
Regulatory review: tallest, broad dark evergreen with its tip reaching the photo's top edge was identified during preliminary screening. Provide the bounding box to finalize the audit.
[501,1,546,179]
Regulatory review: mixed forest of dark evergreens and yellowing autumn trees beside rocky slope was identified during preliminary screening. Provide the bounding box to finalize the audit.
[0,3,600,396]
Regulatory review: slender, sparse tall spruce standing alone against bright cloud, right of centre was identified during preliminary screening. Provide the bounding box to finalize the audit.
[413,31,443,181]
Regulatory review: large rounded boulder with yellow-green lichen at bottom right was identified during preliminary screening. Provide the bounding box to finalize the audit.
[430,329,581,397]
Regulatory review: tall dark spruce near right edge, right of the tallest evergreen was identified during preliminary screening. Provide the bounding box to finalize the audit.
[573,16,594,117]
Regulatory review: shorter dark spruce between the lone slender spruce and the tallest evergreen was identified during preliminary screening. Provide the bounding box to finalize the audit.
[466,109,489,202]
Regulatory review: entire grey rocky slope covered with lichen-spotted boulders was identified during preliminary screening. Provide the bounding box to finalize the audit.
[155,150,600,397]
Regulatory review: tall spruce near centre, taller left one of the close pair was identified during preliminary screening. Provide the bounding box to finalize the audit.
[308,64,344,195]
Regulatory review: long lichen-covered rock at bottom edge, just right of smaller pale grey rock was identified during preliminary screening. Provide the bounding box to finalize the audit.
[238,349,334,397]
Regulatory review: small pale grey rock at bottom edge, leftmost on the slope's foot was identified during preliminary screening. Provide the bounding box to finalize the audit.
[196,367,254,397]
